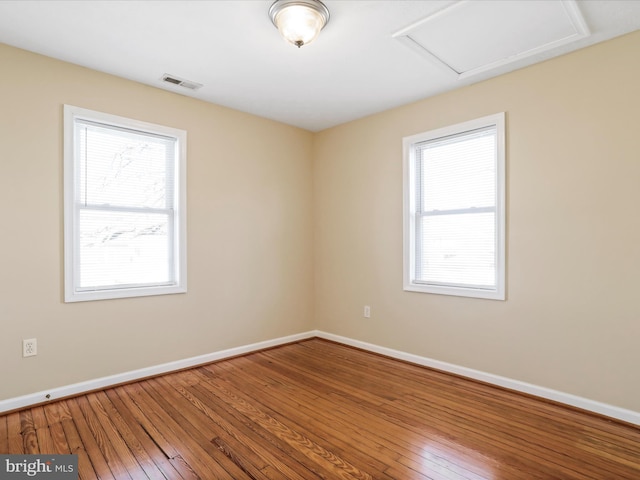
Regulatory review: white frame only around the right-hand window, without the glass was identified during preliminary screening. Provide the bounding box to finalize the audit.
[403,112,506,300]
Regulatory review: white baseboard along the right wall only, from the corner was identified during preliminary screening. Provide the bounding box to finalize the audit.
[314,331,640,425]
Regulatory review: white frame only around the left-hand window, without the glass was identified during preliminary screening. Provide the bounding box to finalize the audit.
[64,105,187,302]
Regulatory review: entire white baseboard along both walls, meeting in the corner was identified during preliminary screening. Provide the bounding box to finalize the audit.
[5,330,640,425]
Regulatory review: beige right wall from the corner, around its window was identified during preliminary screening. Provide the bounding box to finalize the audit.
[314,33,640,411]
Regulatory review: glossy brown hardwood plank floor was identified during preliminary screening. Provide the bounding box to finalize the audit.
[0,339,640,480]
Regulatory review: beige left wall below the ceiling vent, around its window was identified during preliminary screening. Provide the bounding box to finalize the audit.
[0,45,313,400]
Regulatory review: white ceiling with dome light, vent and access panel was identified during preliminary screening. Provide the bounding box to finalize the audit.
[0,0,640,131]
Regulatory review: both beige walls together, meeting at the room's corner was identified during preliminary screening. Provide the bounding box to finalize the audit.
[0,33,640,411]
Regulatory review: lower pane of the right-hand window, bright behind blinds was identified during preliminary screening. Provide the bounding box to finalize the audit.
[416,213,496,288]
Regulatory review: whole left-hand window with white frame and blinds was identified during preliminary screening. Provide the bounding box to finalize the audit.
[64,105,187,302]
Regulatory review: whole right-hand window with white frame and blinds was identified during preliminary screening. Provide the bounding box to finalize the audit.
[404,113,505,300]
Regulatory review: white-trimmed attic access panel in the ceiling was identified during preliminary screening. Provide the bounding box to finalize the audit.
[393,0,589,79]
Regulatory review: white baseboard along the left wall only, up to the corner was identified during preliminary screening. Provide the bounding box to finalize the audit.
[0,332,315,414]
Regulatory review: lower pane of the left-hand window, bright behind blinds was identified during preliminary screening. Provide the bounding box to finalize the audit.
[79,209,174,289]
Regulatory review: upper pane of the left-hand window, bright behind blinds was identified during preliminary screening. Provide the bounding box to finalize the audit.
[78,123,175,208]
